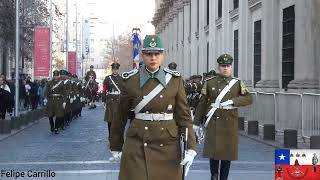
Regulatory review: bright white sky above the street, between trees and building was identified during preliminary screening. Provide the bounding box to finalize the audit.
[77,0,155,37]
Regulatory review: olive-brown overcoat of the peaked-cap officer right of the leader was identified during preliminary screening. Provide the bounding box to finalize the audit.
[194,75,252,160]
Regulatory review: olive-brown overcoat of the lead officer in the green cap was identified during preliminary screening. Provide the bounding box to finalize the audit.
[110,67,196,180]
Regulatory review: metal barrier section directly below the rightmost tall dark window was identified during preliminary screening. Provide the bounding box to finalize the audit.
[275,92,302,135]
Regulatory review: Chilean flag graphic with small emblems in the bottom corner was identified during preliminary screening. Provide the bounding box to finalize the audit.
[274,149,320,180]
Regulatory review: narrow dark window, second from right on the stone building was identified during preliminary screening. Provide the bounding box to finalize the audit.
[253,20,261,87]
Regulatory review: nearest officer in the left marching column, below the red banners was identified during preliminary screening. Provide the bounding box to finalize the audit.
[44,70,65,134]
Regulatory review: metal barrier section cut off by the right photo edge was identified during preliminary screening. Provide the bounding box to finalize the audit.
[302,93,320,137]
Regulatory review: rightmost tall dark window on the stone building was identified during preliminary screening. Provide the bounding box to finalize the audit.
[282,6,295,89]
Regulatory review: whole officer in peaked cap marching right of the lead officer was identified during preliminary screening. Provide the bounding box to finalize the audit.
[194,54,252,180]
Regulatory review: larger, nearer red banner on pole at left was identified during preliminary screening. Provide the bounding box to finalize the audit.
[34,27,50,78]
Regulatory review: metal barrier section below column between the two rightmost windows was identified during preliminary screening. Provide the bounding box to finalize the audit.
[255,92,276,125]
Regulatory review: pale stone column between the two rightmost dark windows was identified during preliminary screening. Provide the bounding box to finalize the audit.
[256,0,280,92]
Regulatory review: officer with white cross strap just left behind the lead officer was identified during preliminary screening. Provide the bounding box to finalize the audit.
[102,62,122,136]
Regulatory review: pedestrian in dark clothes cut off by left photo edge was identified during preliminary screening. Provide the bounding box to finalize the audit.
[0,77,11,120]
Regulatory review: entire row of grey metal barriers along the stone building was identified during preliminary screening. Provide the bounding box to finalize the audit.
[240,92,320,138]
